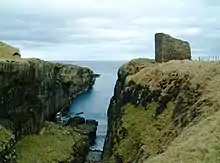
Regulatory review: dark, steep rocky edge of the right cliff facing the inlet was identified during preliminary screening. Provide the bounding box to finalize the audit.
[102,59,154,163]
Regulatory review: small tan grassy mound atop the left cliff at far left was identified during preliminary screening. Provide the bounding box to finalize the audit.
[0,41,21,58]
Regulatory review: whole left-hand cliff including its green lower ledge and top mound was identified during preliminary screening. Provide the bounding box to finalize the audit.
[0,42,96,163]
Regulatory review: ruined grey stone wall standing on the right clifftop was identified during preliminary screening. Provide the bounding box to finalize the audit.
[155,33,191,62]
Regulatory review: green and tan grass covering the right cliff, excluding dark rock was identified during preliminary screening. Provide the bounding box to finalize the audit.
[110,61,220,163]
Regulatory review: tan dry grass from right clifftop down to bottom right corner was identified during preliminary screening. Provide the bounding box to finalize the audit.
[124,60,220,163]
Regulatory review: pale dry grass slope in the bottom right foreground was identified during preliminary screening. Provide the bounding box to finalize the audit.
[145,111,220,163]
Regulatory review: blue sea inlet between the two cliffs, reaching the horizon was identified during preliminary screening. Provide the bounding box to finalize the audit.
[58,61,126,150]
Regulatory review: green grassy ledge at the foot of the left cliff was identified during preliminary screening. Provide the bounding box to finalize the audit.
[15,122,87,163]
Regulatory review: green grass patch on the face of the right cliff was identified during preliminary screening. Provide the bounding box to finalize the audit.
[111,102,176,162]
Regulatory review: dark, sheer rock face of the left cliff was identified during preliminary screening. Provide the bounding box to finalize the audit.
[0,58,94,162]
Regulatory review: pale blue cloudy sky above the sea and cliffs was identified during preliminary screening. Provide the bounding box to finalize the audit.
[0,0,220,60]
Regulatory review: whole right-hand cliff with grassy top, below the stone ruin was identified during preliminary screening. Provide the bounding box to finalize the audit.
[102,59,220,163]
